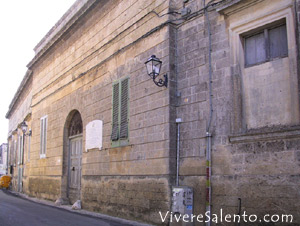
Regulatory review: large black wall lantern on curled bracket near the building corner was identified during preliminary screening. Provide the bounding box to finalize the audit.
[145,55,168,87]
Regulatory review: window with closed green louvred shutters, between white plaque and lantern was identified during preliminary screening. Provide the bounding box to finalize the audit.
[111,78,129,147]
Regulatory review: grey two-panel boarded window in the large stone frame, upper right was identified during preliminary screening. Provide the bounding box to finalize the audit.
[244,20,288,67]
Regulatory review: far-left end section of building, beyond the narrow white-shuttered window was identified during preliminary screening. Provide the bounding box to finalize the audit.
[6,70,32,192]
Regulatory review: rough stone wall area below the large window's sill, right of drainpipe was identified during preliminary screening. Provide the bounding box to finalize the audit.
[212,135,300,225]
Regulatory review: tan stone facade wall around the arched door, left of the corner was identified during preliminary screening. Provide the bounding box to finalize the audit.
[29,1,172,222]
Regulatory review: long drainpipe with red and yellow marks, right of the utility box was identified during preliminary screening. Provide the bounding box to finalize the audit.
[203,0,213,226]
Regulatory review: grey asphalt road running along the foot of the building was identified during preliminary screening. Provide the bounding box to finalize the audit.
[0,190,130,226]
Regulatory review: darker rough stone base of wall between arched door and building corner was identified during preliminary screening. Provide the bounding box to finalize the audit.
[82,176,171,224]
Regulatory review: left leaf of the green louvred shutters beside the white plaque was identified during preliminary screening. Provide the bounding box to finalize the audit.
[111,83,120,141]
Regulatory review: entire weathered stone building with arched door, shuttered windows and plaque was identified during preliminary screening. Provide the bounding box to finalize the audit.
[6,0,300,225]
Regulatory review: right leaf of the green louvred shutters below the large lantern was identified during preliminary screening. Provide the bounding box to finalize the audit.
[120,78,129,139]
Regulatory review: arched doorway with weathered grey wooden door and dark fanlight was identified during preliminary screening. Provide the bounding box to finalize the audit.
[61,110,83,203]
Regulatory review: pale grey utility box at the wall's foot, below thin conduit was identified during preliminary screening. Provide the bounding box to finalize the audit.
[172,186,194,225]
